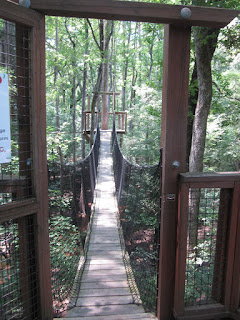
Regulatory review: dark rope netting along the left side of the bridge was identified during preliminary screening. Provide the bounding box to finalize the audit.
[48,125,100,315]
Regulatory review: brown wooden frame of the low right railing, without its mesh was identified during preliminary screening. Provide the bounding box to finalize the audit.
[174,173,240,320]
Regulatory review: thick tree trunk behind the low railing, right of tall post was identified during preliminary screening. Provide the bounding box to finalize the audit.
[189,28,219,247]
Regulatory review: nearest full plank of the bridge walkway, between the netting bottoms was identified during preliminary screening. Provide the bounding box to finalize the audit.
[64,304,144,317]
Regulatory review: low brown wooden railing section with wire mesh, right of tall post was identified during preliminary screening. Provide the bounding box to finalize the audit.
[174,173,240,320]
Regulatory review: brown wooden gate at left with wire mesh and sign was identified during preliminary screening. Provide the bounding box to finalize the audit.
[0,0,52,319]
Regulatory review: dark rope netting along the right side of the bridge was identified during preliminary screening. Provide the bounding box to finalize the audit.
[113,116,161,312]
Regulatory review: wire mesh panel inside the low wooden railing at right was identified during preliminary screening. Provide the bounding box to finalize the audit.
[185,188,226,306]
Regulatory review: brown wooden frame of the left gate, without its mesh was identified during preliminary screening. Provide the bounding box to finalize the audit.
[0,0,52,320]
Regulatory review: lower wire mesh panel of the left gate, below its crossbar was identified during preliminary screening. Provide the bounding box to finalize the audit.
[0,216,39,320]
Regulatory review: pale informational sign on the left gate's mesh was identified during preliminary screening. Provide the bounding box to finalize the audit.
[0,73,11,163]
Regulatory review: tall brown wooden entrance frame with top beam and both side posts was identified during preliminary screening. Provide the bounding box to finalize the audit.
[0,0,240,320]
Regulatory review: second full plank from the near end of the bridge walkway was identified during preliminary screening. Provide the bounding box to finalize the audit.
[76,294,133,307]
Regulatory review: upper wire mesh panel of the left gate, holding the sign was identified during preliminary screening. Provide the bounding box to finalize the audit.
[0,19,32,204]
